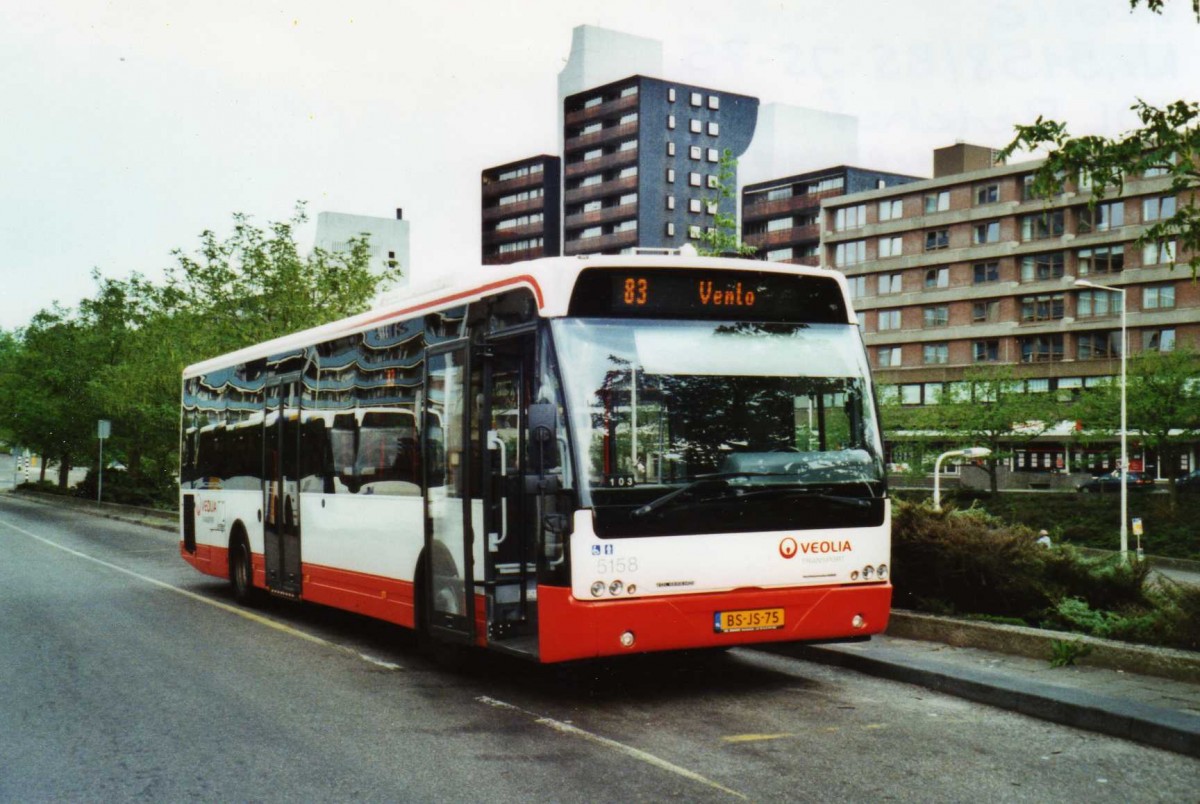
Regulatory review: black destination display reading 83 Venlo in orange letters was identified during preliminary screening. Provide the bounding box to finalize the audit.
[571,269,846,324]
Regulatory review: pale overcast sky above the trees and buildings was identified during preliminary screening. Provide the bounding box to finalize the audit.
[0,0,1200,329]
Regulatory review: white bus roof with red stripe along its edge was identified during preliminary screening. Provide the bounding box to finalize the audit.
[184,254,853,377]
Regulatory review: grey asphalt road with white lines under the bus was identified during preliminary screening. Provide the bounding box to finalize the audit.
[0,494,1200,802]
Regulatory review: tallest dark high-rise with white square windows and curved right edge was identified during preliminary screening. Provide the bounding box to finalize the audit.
[563,76,758,254]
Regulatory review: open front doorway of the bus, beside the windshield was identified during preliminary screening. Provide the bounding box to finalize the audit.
[473,335,538,655]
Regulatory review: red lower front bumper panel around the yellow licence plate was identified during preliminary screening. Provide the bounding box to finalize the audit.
[538,583,892,662]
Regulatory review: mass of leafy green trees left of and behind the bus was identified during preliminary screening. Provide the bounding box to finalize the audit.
[0,206,400,498]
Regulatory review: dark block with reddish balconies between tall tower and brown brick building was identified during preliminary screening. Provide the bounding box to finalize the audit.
[742,166,919,265]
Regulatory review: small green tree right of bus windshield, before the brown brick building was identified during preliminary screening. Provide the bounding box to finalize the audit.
[884,365,1067,494]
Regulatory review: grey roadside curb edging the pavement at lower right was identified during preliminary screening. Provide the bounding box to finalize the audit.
[778,644,1200,758]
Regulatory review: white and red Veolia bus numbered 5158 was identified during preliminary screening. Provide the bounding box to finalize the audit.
[180,254,892,662]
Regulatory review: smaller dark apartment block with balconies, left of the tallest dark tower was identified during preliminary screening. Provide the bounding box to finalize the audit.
[482,154,562,265]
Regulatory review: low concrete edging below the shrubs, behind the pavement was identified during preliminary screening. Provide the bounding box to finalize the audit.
[887,611,1200,684]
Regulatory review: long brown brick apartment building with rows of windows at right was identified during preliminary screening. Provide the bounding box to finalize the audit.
[821,145,1200,480]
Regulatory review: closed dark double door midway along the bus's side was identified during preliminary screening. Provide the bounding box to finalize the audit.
[263,382,301,598]
